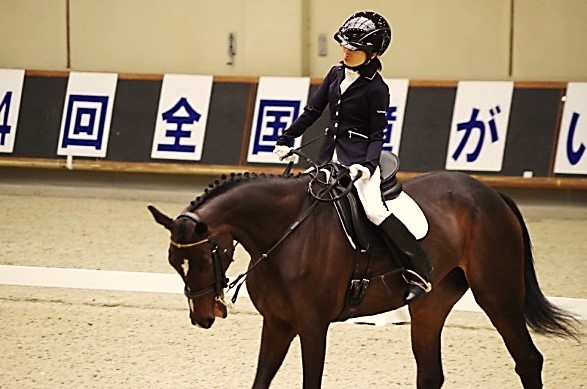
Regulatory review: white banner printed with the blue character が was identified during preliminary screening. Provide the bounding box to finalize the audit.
[446,81,514,172]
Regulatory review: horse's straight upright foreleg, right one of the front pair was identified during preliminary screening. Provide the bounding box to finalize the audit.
[300,324,328,389]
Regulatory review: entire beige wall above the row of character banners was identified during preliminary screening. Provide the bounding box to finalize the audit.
[0,0,587,81]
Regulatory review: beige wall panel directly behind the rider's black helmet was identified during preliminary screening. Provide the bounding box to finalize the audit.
[310,0,510,80]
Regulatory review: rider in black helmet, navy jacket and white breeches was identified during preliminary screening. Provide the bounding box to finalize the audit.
[274,11,432,303]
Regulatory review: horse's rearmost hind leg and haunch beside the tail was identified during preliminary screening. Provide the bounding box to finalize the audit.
[466,201,543,389]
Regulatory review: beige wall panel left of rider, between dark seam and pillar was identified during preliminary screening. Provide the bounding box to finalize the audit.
[71,0,301,75]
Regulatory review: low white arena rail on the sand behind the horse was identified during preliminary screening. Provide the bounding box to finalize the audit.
[0,265,587,326]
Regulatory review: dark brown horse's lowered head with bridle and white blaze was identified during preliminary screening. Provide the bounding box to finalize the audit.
[148,205,234,328]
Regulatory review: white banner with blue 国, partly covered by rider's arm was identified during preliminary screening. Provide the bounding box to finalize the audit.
[247,77,310,163]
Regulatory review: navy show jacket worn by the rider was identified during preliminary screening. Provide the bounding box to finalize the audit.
[276,65,389,173]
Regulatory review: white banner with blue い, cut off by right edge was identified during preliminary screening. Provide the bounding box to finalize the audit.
[554,82,587,174]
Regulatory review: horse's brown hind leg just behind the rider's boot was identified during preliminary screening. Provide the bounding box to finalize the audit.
[410,269,468,389]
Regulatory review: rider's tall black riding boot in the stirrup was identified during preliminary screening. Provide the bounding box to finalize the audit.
[379,215,432,304]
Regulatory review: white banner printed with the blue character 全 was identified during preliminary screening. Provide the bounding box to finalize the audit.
[151,74,213,161]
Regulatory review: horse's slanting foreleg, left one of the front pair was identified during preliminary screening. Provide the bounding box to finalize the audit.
[253,318,295,389]
